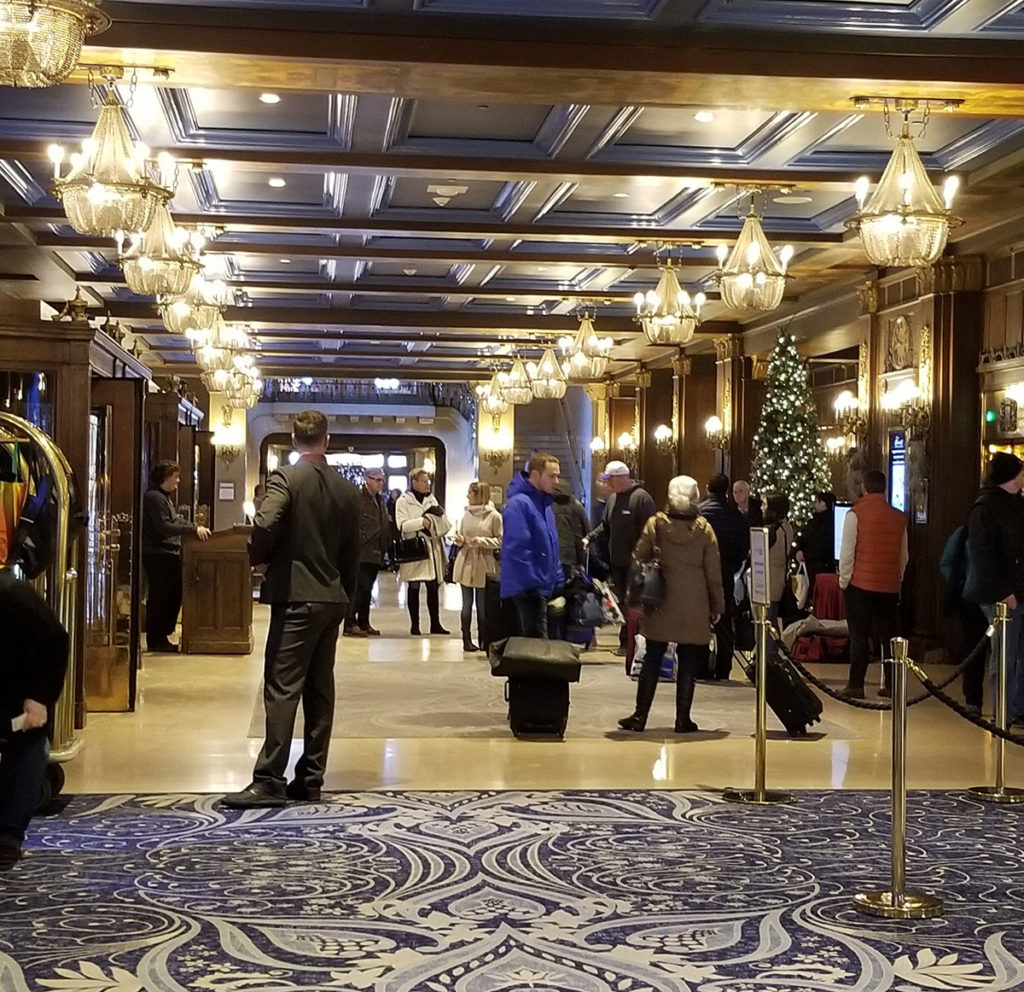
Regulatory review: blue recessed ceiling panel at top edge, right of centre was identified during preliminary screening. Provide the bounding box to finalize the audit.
[697,0,965,32]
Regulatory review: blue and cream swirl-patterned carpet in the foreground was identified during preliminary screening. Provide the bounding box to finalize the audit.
[0,791,1024,992]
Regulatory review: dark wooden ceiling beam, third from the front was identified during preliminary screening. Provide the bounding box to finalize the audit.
[0,204,853,246]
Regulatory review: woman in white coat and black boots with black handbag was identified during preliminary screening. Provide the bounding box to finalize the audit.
[394,469,452,636]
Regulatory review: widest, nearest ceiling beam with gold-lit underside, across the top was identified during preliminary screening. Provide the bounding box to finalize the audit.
[83,3,1024,116]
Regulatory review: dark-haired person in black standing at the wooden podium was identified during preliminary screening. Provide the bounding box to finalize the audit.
[142,462,210,653]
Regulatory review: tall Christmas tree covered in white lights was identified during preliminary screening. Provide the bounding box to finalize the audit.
[751,333,829,526]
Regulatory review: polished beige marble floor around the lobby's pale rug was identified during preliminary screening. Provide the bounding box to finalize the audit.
[66,574,1024,793]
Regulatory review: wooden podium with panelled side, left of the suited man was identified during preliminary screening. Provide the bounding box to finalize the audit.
[181,524,253,654]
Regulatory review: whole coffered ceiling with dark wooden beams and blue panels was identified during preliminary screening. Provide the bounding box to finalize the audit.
[0,0,1024,380]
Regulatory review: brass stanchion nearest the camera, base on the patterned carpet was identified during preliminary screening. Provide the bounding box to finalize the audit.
[853,637,942,919]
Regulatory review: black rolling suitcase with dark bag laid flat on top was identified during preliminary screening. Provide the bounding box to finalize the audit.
[487,637,581,737]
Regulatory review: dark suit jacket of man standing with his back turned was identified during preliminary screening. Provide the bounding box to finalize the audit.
[249,457,359,604]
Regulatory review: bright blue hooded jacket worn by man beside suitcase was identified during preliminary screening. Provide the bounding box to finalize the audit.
[502,472,562,599]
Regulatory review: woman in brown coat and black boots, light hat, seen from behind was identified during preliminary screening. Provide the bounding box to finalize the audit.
[618,475,725,734]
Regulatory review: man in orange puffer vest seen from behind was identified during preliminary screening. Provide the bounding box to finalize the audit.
[839,469,907,699]
